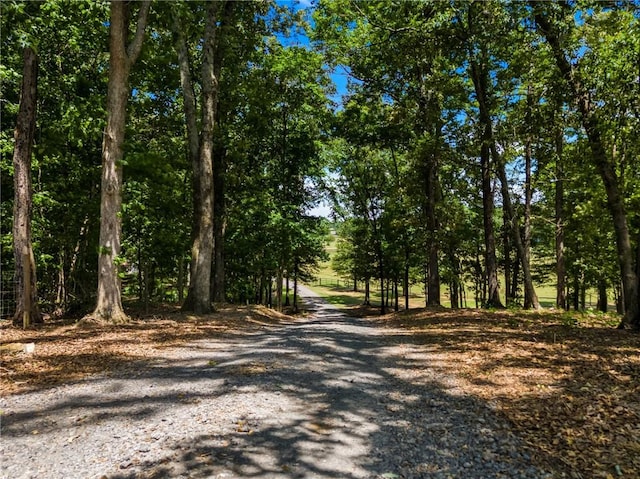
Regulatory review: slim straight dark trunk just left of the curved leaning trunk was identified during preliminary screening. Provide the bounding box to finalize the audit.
[555,118,567,309]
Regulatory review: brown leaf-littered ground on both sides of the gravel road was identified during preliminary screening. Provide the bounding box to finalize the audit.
[0,307,640,479]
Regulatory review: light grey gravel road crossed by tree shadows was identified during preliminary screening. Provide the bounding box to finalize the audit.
[0,288,551,479]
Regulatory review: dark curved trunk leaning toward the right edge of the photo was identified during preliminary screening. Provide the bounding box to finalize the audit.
[534,10,640,329]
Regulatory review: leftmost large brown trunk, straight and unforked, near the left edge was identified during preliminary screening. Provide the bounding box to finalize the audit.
[13,47,42,325]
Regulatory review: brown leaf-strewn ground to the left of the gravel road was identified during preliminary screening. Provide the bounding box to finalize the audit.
[0,306,293,394]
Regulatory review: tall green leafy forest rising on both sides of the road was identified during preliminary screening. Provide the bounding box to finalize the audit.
[0,0,640,329]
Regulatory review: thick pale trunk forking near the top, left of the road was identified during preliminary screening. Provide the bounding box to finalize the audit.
[91,1,150,323]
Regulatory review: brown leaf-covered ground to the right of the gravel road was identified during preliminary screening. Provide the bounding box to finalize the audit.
[370,310,640,478]
